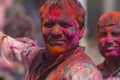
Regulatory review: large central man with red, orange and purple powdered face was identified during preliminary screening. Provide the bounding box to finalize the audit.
[1,0,102,80]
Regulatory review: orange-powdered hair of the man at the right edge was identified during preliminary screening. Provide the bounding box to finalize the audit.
[97,12,120,28]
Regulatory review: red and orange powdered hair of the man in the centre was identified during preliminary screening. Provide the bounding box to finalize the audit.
[39,0,86,29]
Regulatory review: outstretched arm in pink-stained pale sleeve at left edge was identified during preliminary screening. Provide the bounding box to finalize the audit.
[0,32,39,68]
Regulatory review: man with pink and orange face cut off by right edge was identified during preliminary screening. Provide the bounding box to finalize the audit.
[98,12,120,80]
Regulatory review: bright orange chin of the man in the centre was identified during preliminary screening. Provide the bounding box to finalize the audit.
[46,45,65,56]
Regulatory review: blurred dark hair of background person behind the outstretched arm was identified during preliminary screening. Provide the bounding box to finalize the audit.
[3,13,34,39]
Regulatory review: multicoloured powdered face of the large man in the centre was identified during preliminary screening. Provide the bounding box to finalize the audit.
[42,6,84,56]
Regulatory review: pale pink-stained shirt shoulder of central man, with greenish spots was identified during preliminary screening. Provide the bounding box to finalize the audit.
[64,62,102,80]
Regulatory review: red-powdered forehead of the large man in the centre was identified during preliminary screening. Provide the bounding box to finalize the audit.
[43,7,76,21]
